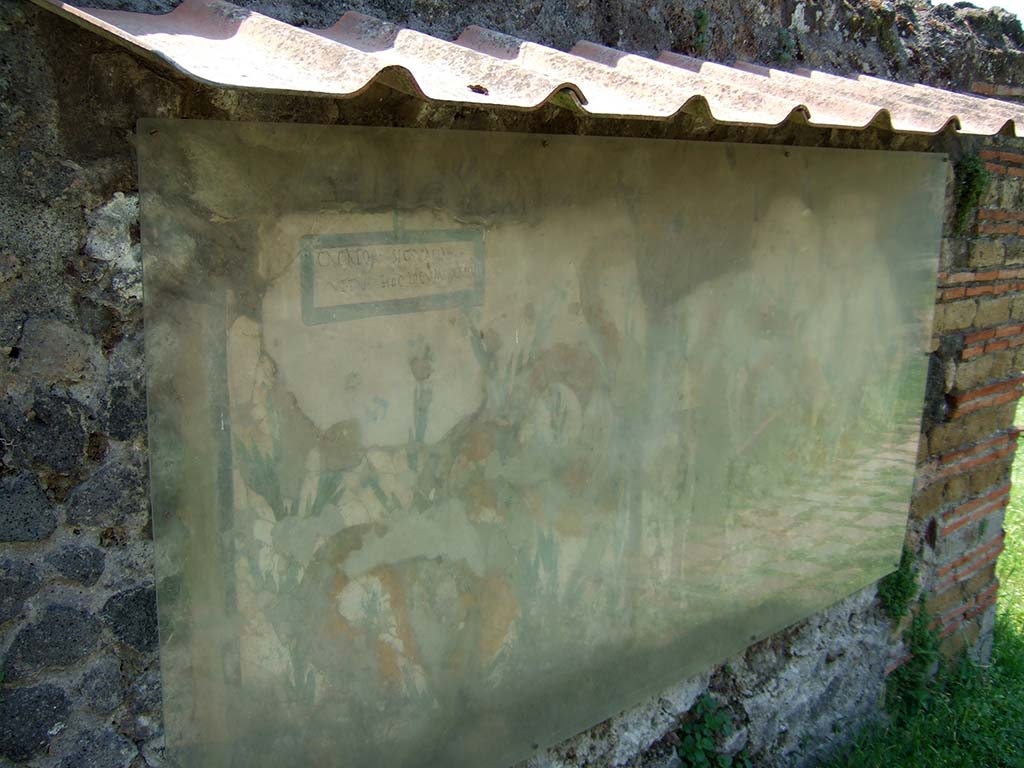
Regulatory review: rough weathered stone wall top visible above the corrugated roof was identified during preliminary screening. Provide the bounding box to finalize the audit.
[48,0,1024,91]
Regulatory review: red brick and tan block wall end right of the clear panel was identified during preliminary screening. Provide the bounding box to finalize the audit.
[910,140,1024,658]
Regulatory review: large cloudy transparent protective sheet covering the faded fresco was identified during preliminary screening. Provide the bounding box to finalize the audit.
[139,121,947,768]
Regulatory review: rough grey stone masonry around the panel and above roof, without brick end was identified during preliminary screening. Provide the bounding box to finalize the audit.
[0,0,1024,768]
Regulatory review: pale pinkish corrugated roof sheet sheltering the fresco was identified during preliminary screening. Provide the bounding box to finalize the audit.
[34,0,1024,135]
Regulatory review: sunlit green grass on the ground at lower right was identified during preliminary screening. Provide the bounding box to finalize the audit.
[828,408,1024,768]
